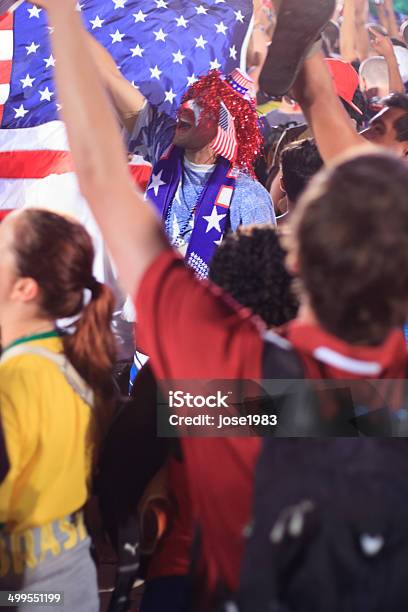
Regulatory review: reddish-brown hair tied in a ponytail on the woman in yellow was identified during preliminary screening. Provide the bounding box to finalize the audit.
[14,209,115,416]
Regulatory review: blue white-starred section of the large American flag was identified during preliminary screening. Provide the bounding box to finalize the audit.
[0,0,252,128]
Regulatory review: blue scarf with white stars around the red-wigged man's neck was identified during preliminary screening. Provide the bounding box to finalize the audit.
[147,146,237,278]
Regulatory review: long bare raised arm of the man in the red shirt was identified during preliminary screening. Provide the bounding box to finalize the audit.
[43,0,166,295]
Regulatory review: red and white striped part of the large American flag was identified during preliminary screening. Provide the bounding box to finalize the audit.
[0,14,151,281]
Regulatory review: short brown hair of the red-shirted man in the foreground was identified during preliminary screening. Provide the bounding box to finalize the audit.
[293,153,408,345]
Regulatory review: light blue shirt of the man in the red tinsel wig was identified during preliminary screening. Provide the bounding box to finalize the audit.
[128,103,275,254]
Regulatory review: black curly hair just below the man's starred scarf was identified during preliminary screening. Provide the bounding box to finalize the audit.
[209,225,298,327]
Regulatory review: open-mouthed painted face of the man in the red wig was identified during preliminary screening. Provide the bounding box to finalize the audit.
[173,100,218,151]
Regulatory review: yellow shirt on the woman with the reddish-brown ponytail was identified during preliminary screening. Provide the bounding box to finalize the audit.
[0,337,94,531]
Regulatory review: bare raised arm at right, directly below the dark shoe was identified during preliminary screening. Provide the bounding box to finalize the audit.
[294,51,367,162]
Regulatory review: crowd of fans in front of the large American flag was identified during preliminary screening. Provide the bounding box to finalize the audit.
[0,0,408,612]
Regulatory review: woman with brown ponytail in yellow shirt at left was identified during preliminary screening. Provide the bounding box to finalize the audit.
[0,209,115,612]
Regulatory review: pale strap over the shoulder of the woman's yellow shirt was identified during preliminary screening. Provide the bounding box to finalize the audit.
[0,343,95,408]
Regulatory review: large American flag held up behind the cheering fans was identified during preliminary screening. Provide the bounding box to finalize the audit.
[0,0,253,208]
